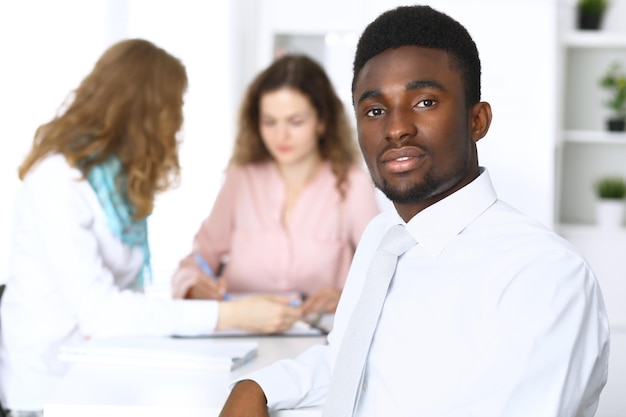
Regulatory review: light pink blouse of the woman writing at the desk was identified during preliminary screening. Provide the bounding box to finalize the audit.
[174,162,379,295]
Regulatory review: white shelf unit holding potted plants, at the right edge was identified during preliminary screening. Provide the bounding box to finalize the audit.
[554,0,626,358]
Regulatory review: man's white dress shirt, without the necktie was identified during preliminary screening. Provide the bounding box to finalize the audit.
[247,169,609,417]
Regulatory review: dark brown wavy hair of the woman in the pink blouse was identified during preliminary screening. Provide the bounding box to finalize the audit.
[230,54,359,196]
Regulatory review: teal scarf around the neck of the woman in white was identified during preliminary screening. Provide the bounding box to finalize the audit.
[87,156,152,288]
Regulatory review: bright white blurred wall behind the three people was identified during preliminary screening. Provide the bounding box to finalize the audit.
[0,0,572,282]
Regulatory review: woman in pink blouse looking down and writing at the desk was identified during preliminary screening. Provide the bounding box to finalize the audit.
[173,55,379,313]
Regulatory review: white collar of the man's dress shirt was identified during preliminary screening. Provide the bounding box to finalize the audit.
[394,167,497,258]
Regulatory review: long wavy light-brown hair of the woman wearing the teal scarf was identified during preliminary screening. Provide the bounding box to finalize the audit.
[18,39,187,220]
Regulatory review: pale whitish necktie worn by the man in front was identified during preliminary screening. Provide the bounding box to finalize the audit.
[322,224,416,417]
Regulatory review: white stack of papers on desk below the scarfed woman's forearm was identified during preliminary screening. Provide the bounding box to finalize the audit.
[59,336,258,371]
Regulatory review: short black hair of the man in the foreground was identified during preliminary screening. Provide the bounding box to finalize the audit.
[352,6,480,107]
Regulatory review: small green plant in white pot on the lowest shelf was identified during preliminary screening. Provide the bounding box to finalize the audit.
[595,175,626,228]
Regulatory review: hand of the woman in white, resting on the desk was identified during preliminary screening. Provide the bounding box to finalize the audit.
[217,295,302,333]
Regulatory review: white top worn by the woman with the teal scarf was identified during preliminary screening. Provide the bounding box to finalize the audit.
[0,155,218,410]
